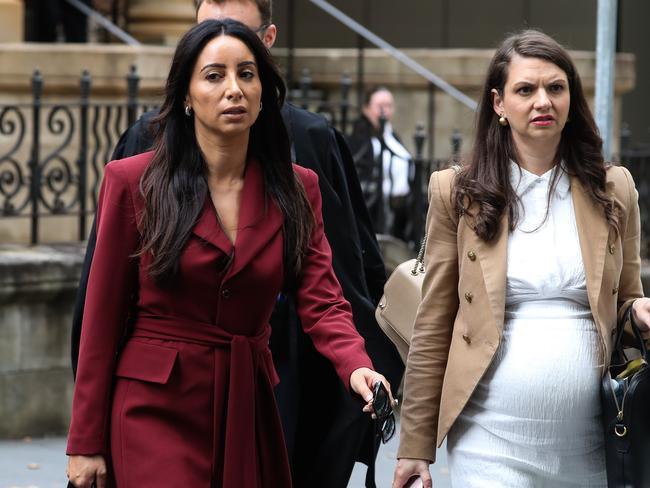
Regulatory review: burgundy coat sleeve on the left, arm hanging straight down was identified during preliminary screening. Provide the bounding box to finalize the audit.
[66,163,139,455]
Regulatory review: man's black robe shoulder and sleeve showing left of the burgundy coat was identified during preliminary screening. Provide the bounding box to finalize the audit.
[70,111,157,377]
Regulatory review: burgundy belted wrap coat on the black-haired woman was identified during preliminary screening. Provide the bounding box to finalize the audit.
[67,153,372,488]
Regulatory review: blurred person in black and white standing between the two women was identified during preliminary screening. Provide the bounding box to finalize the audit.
[349,86,412,241]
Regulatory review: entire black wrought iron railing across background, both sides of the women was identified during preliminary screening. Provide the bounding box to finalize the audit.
[0,66,650,257]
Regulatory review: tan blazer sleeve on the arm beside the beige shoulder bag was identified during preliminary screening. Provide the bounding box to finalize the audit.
[397,170,459,462]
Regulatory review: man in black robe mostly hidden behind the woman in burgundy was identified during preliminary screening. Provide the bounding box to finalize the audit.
[72,0,404,488]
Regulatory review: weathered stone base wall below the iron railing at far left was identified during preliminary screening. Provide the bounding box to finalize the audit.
[0,245,83,438]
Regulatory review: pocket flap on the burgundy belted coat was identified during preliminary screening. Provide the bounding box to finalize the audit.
[115,340,178,384]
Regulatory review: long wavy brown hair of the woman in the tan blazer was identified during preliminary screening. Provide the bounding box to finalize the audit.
[454,29,618,241]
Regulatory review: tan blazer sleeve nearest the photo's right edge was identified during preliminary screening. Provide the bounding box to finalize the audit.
[610,167,648,339]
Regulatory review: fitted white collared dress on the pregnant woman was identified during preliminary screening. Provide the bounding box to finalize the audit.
[447,163,607,488]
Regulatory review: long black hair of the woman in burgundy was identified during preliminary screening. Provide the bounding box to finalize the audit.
[140,19,314,286]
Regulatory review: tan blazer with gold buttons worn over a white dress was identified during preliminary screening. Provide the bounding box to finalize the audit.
[397,166,643,462]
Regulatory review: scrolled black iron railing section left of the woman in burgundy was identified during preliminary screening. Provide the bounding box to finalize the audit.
[0,66,153,244]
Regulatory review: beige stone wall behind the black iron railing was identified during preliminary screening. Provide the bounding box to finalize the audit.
[0,43,635,243]
